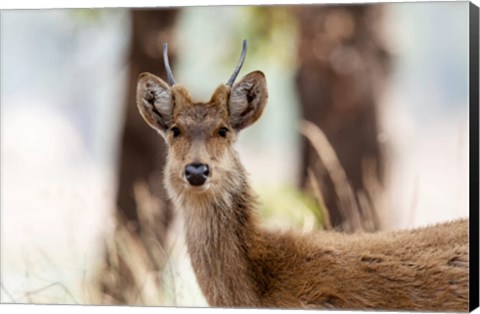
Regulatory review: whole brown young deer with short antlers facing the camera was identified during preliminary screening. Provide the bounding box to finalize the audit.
[137,41,468,311]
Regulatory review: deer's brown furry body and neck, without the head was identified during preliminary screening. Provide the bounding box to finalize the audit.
[177,155,468,311]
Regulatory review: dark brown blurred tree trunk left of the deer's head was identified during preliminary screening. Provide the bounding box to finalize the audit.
[117,9,177,243]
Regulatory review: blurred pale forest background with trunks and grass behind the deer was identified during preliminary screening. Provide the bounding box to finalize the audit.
[1,2,468,306]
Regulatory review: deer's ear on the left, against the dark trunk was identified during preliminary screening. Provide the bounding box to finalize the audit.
[137,73,173,133]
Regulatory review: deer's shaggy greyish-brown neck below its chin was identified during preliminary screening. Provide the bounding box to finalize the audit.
[175,166,257,306]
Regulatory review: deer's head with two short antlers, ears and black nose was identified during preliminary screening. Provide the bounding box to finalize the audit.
[137,41,268,200]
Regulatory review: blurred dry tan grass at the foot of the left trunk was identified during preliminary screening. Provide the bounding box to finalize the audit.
[92,183,175,305]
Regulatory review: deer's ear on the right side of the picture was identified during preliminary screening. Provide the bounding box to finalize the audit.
[228,71,268,130]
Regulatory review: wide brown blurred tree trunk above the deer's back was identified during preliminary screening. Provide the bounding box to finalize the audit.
[297,5,390,232]
